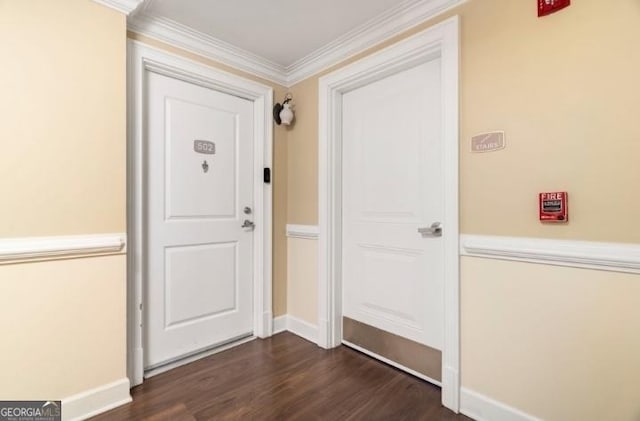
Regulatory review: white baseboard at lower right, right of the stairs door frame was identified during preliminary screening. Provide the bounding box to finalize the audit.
[460,387,540,421]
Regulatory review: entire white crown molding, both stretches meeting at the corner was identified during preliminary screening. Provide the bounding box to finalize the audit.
[126,0,467,87]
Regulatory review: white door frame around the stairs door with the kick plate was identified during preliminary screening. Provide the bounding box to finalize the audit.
[318,16,460,412]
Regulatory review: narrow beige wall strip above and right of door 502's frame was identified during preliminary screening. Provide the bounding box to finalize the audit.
[127,32,289,317]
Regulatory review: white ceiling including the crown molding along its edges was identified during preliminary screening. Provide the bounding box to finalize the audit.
[127,0,460,87]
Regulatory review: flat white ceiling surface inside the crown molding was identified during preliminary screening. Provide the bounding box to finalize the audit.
[134,0,406,68]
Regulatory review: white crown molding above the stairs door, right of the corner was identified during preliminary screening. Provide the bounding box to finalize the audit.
[286,0,467,86]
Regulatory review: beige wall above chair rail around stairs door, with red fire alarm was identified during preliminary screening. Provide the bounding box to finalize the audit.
[288,0,640,242]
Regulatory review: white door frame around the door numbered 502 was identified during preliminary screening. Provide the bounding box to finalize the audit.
[127,40,273,386]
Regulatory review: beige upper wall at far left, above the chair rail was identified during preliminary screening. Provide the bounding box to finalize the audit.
[0,0,126,237]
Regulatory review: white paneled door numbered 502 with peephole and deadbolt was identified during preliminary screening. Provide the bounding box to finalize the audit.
[143,72,254,369]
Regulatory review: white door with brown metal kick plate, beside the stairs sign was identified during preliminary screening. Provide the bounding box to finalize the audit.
[342,58,447,382]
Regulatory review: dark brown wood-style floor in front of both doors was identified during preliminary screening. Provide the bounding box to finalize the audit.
[93,332,469,421]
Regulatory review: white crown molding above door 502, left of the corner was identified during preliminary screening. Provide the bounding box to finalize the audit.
[128,14,287,86]
